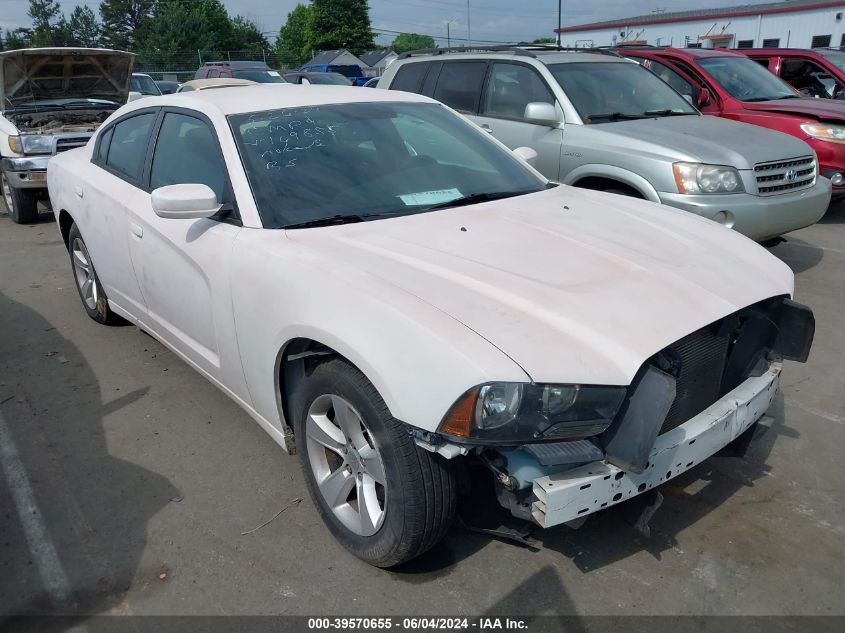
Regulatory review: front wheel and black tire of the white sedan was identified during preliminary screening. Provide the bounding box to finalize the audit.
[292,359,457,567]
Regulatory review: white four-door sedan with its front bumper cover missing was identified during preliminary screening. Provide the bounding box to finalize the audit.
[48,86,814,567]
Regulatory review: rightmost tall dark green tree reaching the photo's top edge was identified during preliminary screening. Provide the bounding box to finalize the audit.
[308,0,375,55]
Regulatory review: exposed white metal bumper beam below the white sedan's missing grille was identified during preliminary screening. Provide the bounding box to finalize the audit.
[531,363,781,527]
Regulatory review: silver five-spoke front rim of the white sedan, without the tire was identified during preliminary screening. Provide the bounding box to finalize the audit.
[305,394,387,536]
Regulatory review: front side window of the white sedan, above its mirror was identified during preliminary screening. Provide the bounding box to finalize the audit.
[150,112,226,202]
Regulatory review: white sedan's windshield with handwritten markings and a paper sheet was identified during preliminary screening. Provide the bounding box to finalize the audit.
[229,103,545,228]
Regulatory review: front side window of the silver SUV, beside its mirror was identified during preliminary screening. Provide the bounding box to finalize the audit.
[481,64,555,119]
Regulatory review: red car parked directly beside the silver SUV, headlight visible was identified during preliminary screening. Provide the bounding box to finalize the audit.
[623,48,845,199]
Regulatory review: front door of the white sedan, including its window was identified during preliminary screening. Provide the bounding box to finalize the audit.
[129,108,248,400]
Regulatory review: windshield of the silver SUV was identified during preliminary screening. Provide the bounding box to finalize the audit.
[549,62,698,123]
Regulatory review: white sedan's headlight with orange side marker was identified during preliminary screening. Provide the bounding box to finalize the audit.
[439,382,627,445]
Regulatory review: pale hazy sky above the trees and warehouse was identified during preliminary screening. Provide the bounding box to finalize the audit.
[0,0,753,46]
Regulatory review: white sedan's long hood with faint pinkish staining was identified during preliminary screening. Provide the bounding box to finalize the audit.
[287,186,793,385]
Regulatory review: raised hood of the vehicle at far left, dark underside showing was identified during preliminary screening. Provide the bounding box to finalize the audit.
[0,48,135,110]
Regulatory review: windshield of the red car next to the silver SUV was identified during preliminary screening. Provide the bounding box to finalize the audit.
[698,55,799,101]
